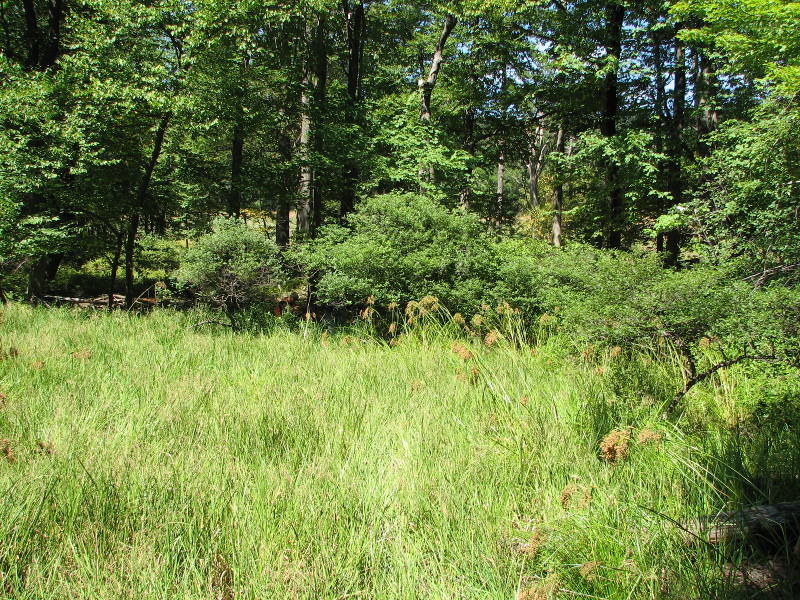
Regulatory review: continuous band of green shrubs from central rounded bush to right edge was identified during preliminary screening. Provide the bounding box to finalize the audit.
[286,194,800,356]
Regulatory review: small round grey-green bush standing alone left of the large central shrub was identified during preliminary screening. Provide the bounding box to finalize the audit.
[175,218,285,317]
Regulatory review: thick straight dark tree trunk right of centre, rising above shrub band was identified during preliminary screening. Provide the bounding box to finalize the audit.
[600,3,625,249]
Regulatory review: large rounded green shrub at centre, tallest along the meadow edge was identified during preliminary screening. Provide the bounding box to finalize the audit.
[296,194,497,311]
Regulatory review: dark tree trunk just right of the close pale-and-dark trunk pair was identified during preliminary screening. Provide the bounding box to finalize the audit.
[339,0,364,219]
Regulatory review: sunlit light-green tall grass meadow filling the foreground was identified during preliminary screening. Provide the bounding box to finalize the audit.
[0,305,800,600]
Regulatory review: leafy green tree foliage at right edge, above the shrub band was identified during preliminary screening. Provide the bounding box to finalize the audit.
[675,99,800,276]
